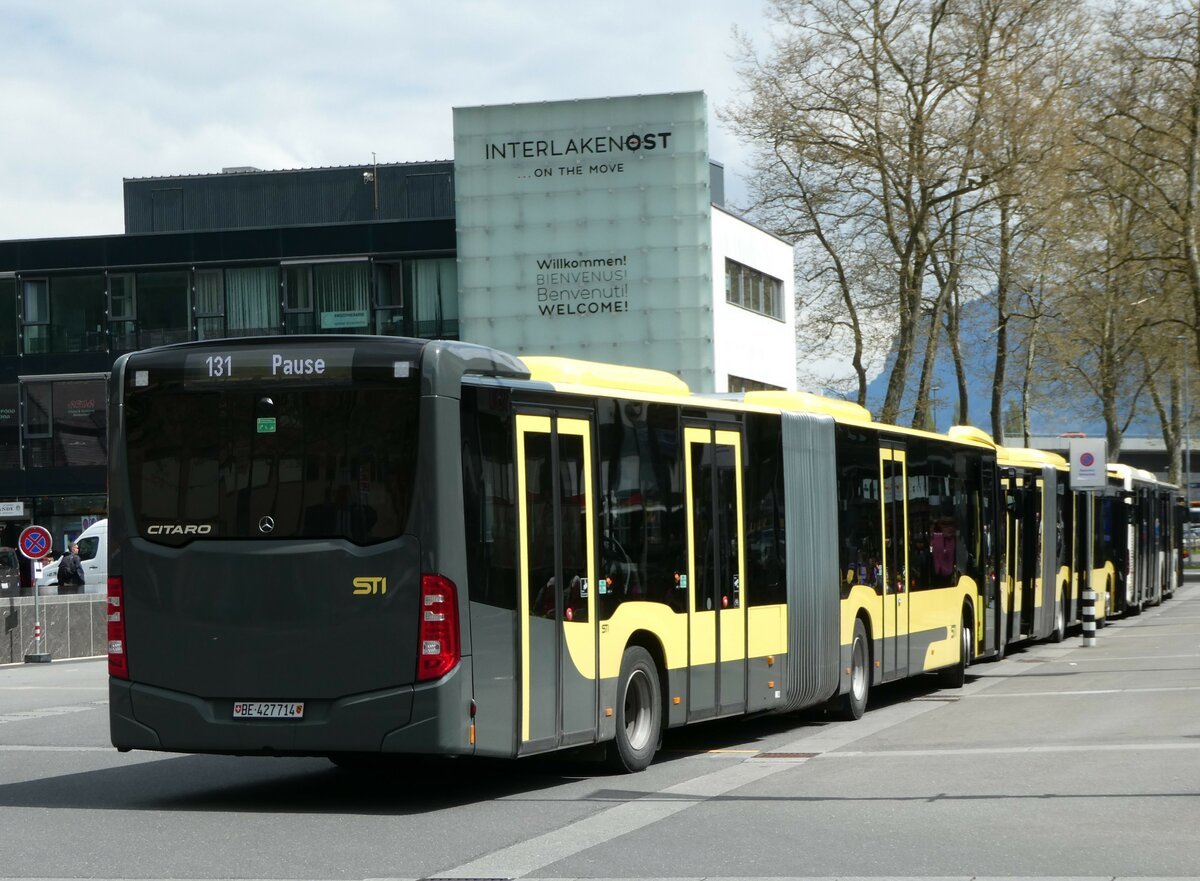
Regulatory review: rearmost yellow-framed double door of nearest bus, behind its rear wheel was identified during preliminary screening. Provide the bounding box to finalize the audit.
[516,414,599,753]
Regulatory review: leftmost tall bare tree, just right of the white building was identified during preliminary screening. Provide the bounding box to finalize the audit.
[724,0,984,421]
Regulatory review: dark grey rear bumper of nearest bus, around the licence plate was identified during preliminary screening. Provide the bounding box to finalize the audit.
[108,658,473,755]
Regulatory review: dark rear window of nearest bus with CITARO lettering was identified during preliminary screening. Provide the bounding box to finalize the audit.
[126,382,419,545]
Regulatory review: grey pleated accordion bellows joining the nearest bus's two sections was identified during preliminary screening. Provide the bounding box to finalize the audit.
[780,413,840,711]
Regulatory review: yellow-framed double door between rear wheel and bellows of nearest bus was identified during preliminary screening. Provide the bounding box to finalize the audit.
[684,426,746,720]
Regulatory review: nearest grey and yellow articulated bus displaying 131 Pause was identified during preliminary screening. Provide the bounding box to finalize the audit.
[109,336,1012,771]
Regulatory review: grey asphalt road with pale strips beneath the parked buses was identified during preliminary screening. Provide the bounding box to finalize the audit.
[0,585,1200,879]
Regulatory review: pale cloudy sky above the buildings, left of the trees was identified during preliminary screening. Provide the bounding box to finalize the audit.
[0,0,770,240]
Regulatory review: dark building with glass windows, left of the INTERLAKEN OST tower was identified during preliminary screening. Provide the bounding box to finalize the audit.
[0,161,458,568]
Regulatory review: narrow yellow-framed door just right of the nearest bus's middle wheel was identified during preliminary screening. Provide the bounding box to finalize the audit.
[880,445,910,681]
